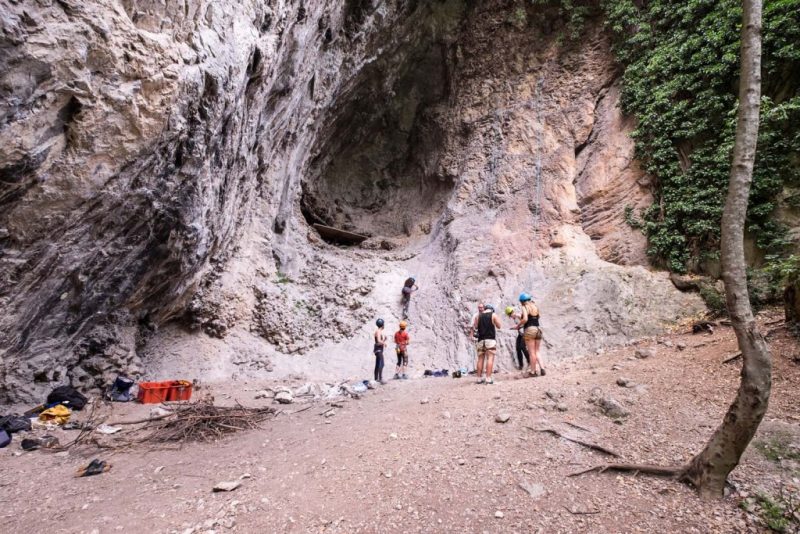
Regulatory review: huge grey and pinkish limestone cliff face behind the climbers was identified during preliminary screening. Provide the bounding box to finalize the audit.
[0,0,700,398]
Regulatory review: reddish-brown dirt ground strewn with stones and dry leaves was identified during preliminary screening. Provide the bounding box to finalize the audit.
[0,316,800,533]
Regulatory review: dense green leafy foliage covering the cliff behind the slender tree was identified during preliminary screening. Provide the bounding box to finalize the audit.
[600,0,800,272]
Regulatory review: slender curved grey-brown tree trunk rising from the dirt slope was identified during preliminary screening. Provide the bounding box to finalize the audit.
[683,0,772,497]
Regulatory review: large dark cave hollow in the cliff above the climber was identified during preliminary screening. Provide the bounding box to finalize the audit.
[300,38,455,244]
